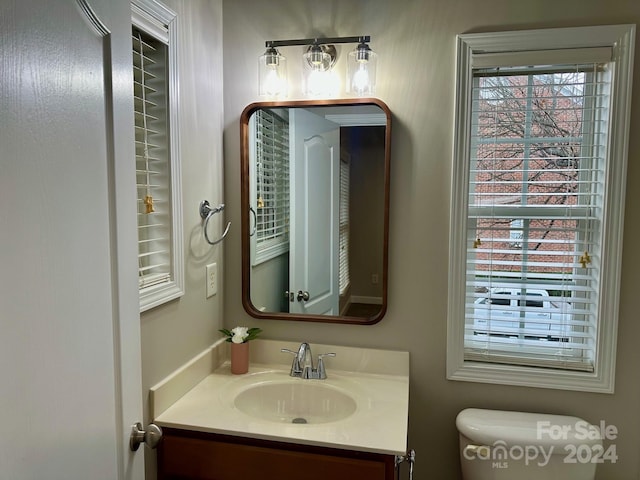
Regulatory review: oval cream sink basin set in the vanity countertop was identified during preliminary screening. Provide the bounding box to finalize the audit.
[234,380,356,424]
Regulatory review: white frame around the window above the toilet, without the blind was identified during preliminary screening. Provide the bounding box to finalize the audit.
[447,25,635,393]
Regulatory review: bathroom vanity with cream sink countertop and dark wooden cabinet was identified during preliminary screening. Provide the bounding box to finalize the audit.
[151,340,409,480]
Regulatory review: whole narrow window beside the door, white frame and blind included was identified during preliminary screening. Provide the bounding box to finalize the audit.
[132,0,183,311]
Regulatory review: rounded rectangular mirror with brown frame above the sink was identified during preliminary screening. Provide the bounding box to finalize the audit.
[241,99,391,323]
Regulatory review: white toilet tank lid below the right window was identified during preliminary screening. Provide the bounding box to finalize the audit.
[456,408,602,447]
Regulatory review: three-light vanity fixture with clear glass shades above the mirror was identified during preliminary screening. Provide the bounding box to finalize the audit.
[258,35,377,98]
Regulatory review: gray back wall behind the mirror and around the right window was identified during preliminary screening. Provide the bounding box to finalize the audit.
[222,0,640,480]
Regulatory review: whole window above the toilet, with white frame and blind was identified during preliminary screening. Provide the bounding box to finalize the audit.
[447,26,634,392]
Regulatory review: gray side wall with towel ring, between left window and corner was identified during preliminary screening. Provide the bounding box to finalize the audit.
[141,0,224,479]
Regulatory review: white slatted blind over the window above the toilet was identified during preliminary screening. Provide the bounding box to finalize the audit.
[464,63,610,372]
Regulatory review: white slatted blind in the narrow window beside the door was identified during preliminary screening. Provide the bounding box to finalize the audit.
[132,26,172,290]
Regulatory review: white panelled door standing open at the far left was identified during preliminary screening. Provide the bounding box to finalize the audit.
[0,0,144,480]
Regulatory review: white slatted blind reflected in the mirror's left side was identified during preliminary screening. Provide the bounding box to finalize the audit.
[254,109,289,263]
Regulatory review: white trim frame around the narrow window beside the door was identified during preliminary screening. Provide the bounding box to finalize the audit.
[131,0,184,313]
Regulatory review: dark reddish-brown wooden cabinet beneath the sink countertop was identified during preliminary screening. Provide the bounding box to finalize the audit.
[158,428,397,480]
